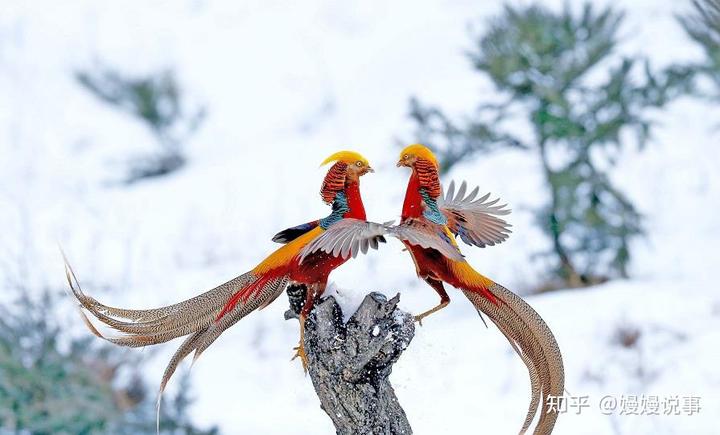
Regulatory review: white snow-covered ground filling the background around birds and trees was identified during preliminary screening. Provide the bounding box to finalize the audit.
[0,0,720,435]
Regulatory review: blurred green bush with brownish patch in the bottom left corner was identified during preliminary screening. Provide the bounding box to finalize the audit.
[0,292,218,435]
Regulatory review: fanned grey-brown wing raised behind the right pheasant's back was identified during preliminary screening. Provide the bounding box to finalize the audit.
[438,181,512,248]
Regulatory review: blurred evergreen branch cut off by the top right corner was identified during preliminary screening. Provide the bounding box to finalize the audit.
[678,0,720,102]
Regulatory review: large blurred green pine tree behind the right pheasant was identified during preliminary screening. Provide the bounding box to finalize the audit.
[411,3,691,288]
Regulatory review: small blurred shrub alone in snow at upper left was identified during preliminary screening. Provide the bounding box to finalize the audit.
[75,66,205,183]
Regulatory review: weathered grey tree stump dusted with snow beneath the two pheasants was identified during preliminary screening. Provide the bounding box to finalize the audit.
[285,286,415,435]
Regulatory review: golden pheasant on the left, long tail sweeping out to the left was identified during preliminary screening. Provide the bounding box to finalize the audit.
[65,151,385,397]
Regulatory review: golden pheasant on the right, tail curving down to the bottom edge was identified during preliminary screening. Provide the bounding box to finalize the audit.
[301,144,565,435]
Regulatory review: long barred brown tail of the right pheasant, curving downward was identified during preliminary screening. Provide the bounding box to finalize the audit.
[463,283,565,435]
